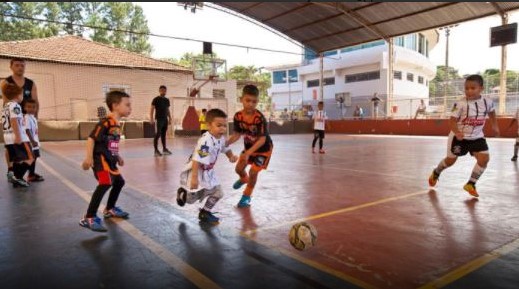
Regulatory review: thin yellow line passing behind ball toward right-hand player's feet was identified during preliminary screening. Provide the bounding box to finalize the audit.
[244,190,430,234]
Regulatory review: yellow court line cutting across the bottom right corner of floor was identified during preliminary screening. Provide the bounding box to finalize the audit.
[418,238,519,289]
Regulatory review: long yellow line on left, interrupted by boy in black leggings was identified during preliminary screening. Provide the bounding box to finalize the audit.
[38,160,221,289]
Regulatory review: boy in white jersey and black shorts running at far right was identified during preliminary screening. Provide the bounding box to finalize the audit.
[429,75,499,197]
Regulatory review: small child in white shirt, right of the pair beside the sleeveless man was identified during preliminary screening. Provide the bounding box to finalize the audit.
[24,98,44,182]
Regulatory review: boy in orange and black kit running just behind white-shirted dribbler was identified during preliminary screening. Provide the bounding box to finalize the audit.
[227,85,274,208]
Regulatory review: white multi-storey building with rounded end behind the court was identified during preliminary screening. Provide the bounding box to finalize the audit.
[268,30,439,118]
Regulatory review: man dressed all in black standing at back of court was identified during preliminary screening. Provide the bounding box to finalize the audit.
[150,85,171,157]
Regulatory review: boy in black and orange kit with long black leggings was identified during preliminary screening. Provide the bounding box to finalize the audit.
[79,91,132,232]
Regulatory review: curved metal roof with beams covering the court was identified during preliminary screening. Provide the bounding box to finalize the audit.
[214,2,519,52]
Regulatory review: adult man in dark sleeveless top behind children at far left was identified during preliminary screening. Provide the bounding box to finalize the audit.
[1,58,40,182]
